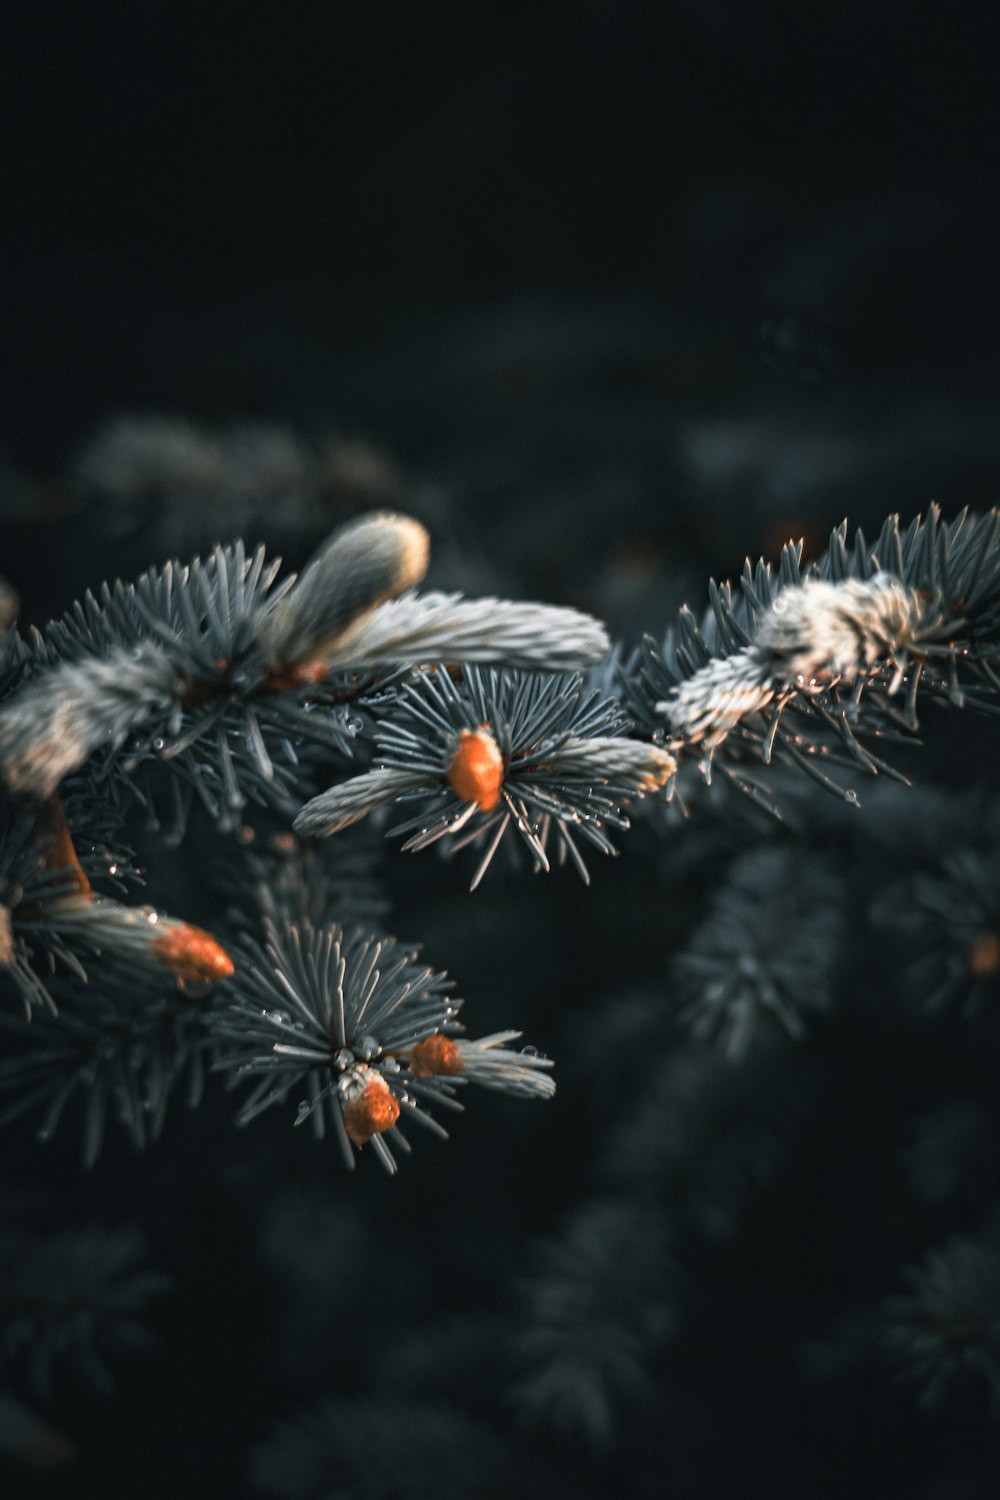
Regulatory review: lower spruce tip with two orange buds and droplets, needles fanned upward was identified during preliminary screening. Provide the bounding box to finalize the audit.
[210,918,553,1173]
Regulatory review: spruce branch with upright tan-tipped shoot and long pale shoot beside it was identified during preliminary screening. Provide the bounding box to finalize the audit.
[0,513,607,828]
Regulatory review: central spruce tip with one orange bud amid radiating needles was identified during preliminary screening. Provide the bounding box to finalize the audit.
[295,668,675,888]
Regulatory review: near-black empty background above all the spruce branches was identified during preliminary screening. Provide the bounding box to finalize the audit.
[7,0,1000,572]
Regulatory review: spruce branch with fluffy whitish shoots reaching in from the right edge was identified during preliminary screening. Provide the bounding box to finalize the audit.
[638,507,1000,801]
